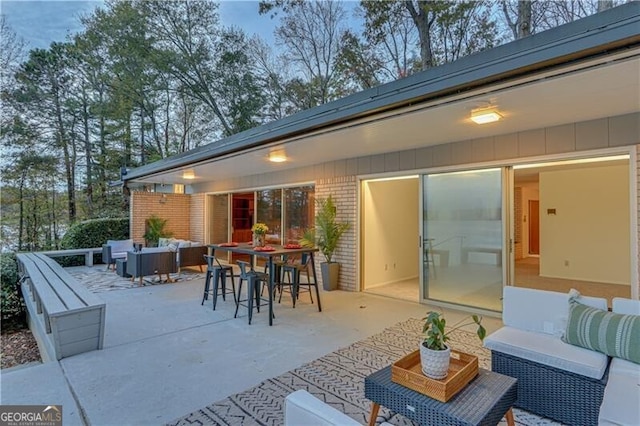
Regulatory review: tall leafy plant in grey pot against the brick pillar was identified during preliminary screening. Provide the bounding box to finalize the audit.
[300,196,350,290]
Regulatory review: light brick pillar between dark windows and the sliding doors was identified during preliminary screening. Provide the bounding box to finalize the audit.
[315,176,360,291]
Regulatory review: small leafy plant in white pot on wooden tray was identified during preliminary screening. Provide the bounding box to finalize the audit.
[420,311,487,379]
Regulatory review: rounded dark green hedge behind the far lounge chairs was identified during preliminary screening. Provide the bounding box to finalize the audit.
[57,218,129,266]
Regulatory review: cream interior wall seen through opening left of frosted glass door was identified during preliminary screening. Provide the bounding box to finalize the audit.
[362,178,419,288]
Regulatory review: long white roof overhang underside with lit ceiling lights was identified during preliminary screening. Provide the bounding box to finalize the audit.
[135,51,640,184]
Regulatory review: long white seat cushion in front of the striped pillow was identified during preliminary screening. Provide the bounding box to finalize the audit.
[484,326,608,379]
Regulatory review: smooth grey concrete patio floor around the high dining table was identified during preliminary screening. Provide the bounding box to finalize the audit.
[0,265,501,426]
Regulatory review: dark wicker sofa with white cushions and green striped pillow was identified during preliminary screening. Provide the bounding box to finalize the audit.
[484,287,640,426]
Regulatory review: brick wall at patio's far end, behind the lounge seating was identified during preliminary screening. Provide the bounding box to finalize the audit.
[130,191,190,242]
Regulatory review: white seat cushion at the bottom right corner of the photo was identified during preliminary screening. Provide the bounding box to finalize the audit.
[598,358,640,426]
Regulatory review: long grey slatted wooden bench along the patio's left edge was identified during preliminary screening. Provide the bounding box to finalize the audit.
[18,253,106,360]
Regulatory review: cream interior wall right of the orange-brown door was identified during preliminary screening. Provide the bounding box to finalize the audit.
[540,165,631,285]
